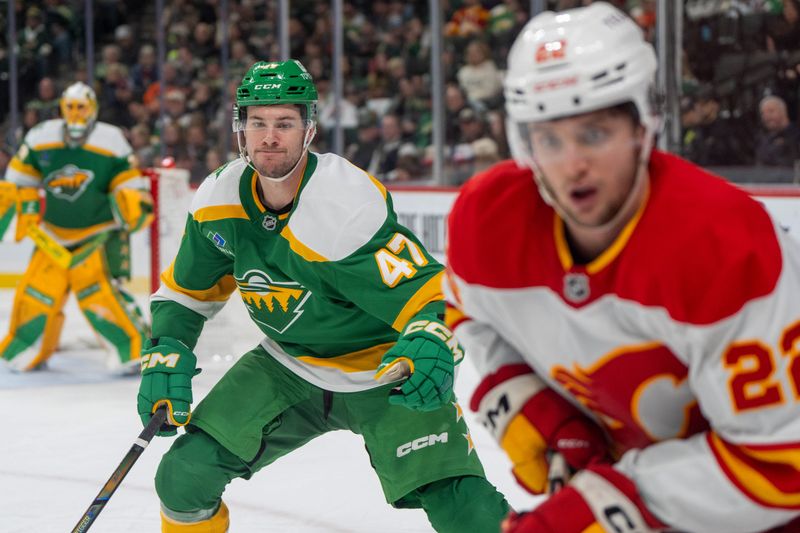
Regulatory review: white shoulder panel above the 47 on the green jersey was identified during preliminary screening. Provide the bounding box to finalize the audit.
[289,154,389,261]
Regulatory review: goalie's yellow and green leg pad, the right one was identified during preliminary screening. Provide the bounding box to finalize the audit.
[69,248,147,367]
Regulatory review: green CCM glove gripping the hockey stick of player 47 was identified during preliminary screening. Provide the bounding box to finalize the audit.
[137,337,200,436]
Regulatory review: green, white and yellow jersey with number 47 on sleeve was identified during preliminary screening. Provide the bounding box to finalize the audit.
[151,153,444,392]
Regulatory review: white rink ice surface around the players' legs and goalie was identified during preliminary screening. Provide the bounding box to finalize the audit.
[0,290,536,533]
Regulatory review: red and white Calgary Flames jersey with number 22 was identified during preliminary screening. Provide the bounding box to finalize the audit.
[445,152,800,532]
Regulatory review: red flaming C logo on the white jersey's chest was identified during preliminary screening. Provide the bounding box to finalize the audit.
[551,343,708,453]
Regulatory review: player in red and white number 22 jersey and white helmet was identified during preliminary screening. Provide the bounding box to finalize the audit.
[446,2,800,533]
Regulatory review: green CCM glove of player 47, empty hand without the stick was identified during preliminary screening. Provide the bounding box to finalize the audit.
[375,314,464,411]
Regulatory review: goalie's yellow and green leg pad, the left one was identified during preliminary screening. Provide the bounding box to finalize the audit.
[0,250,69,371]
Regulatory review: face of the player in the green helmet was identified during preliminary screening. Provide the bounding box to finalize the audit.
[244,105,306,178]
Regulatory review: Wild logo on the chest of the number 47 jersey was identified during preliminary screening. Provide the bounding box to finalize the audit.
[236,269,311,333]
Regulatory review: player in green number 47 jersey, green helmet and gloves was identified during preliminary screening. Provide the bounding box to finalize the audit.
[138,61,508,533]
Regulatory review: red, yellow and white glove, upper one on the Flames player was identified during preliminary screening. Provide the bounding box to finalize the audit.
[470,364,609,494]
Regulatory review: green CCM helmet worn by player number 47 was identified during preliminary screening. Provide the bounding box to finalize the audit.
[233,60,318,181]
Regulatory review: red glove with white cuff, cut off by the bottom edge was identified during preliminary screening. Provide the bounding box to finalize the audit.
[502,465,667,533]
